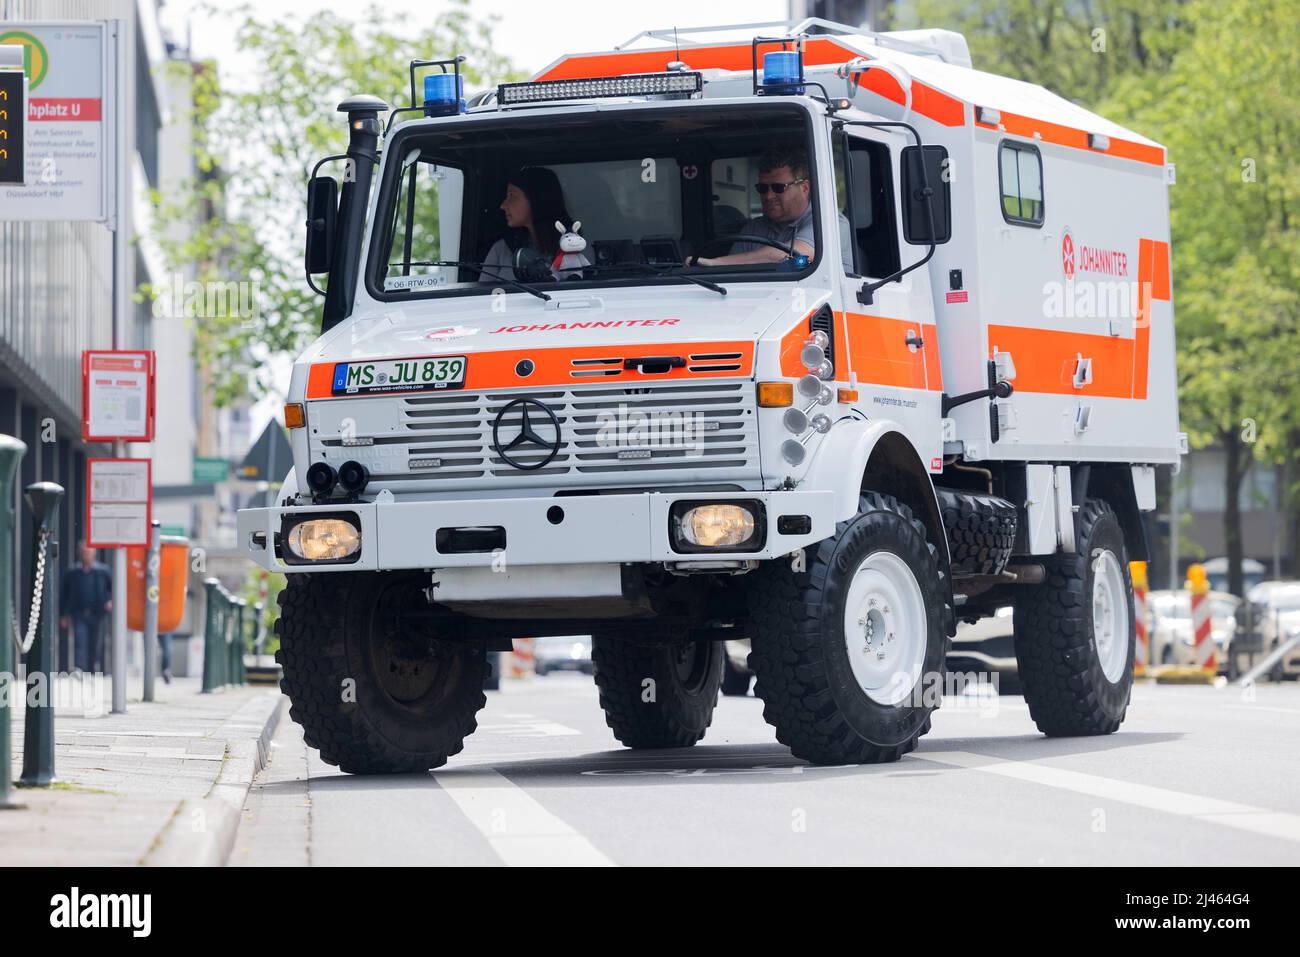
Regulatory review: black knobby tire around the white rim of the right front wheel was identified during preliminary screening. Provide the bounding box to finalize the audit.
[749,493,950,765]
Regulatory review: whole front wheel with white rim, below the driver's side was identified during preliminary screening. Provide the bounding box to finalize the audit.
[749,493,949,765]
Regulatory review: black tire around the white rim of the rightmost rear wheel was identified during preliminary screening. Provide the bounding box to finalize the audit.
[1011,498,1138,737]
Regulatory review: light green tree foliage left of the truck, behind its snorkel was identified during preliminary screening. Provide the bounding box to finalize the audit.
[146,0,519,404]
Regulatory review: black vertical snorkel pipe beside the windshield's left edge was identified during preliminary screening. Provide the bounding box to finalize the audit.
[321,94,389,332]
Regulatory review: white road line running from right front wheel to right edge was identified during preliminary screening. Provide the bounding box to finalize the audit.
[914,752,1300,841]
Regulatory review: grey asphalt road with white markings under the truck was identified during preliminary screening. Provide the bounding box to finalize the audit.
[230,675,1300,866]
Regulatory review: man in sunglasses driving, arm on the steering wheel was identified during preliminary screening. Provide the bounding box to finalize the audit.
[688,147,842,265]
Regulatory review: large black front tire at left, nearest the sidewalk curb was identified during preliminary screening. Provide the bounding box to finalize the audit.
[276,572,488,774]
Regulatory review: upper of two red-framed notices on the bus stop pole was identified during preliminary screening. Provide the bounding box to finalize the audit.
[82,350,153,442]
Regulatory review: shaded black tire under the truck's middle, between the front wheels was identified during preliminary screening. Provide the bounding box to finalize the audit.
[592,635,727,749]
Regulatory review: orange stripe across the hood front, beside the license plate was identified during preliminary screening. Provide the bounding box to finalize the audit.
[307,342,754,399]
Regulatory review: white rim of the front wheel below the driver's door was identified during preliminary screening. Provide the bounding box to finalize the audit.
[844,551,930,706]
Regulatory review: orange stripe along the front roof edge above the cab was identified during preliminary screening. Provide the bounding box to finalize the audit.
[533,39,966,126]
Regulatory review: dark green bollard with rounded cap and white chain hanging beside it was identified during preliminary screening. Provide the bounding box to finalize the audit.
[18,482,64,788]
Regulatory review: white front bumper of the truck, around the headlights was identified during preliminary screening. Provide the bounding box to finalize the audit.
[239,490,835,573]
